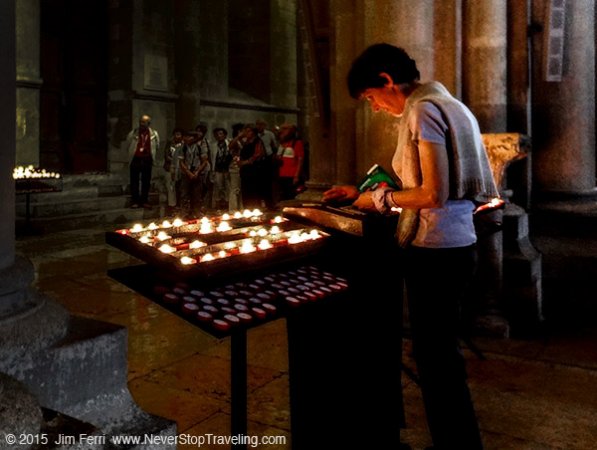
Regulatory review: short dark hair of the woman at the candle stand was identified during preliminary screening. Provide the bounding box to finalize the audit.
[347,43,421,98]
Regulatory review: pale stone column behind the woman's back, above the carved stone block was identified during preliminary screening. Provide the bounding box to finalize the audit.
[463,0,507,133]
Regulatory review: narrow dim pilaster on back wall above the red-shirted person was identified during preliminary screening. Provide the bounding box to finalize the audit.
[270,0,297,108]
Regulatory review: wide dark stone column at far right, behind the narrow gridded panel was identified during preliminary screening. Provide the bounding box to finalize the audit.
[533,0,595,195]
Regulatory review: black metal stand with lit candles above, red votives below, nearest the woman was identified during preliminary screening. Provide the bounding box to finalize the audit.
[106,211,348,449]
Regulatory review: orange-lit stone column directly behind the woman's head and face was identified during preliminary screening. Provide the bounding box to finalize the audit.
[356,0,434,178]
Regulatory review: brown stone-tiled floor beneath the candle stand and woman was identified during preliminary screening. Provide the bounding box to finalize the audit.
[17,215,597,450]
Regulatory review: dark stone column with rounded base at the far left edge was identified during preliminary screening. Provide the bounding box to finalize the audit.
[0,0,68,365]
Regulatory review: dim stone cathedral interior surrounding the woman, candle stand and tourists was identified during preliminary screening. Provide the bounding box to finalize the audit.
[0,0,597,450]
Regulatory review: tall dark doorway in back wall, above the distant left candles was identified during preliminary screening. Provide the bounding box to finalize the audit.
[40,0,108,173]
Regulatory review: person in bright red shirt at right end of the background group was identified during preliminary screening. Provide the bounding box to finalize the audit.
[276,123,305,200]
